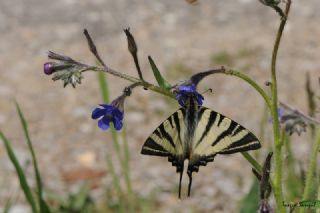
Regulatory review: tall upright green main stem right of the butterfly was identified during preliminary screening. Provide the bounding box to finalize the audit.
[271,0,291,212]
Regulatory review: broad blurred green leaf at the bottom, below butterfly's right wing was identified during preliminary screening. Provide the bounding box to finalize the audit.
[240,178,260,213]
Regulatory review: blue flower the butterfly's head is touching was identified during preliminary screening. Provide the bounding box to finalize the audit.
[176,84,204,107]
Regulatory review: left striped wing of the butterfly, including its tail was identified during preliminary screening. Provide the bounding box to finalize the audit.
[141,109,186,198]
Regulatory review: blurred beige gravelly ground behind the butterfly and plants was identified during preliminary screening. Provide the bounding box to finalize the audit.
[0,0,320,212]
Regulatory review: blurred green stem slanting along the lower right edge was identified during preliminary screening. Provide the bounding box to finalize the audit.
[300,128,320,213]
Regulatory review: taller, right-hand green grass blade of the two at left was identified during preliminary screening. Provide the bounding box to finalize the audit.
[16,102,51,213]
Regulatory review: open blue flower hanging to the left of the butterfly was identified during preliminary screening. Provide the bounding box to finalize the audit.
[91,104,123,131]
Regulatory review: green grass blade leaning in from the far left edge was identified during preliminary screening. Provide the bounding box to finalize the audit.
[0,131,38,213]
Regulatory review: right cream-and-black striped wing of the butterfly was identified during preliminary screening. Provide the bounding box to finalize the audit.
[188,107,261,183]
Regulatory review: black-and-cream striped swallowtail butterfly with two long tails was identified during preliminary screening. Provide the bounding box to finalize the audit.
[141,95,261,198]
